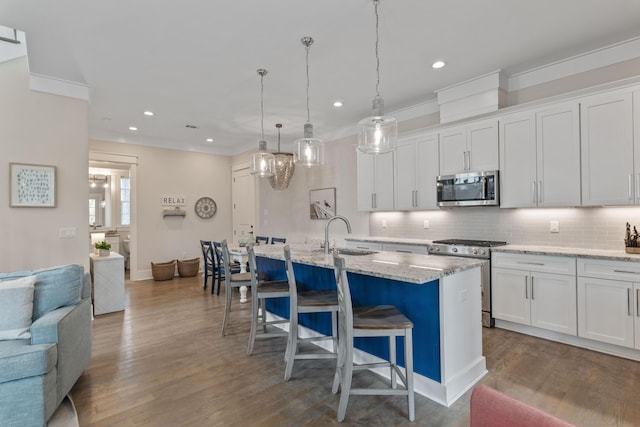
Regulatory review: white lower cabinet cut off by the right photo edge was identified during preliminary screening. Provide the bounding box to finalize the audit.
[578,259,640,349]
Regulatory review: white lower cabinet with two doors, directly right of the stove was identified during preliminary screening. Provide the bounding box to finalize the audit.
[491,253,577,335]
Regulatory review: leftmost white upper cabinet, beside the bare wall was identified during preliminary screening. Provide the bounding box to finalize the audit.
[357,152,394,211]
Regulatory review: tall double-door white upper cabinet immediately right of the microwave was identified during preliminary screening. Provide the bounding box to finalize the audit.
[500,102,580,208]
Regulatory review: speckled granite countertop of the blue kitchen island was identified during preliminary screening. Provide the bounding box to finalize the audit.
[255,243,487,284]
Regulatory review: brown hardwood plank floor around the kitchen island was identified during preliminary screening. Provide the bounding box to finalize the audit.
[71,275,640,427]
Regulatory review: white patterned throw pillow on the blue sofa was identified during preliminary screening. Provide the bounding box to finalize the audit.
[0,276,36,340]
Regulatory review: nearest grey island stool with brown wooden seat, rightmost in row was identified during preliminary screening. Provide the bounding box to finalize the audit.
[331,253,415,422]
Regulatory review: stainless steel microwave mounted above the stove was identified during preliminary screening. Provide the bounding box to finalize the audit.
[436,171,500,207]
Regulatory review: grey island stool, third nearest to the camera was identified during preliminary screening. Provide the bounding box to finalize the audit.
[247,244,289,356]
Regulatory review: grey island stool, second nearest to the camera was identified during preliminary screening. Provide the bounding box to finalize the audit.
[284,245,338,381]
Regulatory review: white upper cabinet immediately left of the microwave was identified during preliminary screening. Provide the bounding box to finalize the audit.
[395,133,439,210]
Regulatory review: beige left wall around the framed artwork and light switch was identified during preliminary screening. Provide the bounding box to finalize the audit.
[0,57,89,271]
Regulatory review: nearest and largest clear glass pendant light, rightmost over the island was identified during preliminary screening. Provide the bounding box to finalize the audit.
[358,0,398,154]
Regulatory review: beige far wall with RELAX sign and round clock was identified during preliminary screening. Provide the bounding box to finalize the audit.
[84,141,232,279]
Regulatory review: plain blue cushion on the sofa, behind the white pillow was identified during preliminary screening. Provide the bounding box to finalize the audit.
[33,265,84,320]
